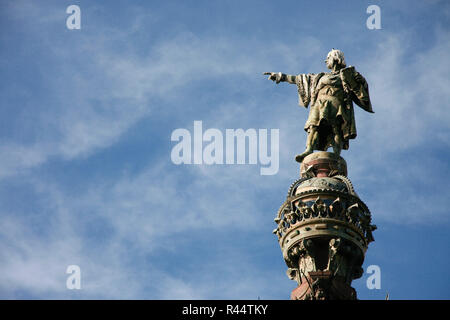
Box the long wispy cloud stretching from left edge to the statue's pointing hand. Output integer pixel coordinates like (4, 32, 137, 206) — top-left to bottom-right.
(0, 3, 320, 180)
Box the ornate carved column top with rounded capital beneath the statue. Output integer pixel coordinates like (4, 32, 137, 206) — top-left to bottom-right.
(273, 151, 376, 300)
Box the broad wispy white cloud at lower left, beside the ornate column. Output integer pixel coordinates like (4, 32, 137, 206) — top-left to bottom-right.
(0, 159, 284, 299)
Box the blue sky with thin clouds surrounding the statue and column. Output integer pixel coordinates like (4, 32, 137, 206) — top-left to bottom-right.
(0, 0, 450, 299)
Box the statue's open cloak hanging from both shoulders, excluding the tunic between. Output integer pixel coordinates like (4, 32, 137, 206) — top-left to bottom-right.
(296, 67, 373, 150)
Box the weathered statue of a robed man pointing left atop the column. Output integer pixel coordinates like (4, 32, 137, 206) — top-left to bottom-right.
(264, 49, 373, 162)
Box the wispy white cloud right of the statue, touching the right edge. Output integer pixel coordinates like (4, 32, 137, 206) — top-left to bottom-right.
(361, 31, 450, 152)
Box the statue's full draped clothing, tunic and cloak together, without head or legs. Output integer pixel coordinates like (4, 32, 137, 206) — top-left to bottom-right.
(295, 67, 373, 150)
